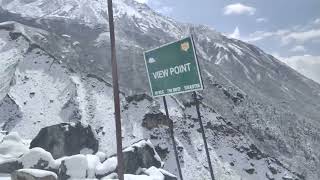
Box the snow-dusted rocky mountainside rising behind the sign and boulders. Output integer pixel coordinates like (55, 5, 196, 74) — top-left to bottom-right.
(0, 0, 320, 180)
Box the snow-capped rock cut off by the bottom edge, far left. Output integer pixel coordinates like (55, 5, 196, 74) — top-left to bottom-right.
(11, 169, 58, 180)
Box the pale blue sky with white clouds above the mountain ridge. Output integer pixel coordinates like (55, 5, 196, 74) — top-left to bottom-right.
(136, 0, 320, 83)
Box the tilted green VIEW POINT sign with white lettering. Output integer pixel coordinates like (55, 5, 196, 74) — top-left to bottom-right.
(144, 37, 203, 97)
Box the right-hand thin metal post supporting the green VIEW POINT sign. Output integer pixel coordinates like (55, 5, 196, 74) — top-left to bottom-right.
(192, 91, 214, 180)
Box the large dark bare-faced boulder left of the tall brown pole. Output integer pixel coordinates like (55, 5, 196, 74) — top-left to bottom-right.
(30, 123, 99, 159)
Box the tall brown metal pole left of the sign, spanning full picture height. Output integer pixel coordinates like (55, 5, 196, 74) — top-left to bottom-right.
(108, 0, 124, 180)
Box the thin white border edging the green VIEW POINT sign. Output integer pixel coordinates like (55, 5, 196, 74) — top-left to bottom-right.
(143, 35, 204, 97)
